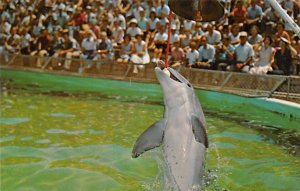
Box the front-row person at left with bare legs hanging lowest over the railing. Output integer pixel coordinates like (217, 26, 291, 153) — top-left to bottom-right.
(53, 30, 81, 70)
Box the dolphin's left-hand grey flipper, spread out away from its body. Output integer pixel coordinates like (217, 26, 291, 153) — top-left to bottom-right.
(132, 119, 165, 158)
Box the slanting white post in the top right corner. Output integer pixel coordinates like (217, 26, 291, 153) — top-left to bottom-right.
(266, 0, 300, 37)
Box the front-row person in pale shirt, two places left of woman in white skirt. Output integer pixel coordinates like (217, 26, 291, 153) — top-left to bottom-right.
(93, 32, 113, 66)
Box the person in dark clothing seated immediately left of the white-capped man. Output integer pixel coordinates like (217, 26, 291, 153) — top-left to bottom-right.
(213, 36, 235, 71)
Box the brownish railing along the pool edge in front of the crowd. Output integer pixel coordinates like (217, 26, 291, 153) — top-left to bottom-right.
(0, 54, 300, 103)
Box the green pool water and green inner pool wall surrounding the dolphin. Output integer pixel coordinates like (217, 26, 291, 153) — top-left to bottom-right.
(0, 71, 300, 191)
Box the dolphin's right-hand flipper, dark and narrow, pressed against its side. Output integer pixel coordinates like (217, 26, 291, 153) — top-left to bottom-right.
(192, 115, 208, 148)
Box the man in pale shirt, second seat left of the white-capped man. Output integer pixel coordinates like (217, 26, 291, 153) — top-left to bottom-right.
(194, 36, 216, 69)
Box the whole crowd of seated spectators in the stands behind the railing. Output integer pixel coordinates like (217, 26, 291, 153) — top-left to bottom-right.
(0, 0, 300, 75)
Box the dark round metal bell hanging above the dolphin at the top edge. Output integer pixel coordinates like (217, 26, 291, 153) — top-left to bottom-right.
(168, 0, 224, 22)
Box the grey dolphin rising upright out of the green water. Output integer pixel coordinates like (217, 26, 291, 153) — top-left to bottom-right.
(132, 67, 208, 191)
